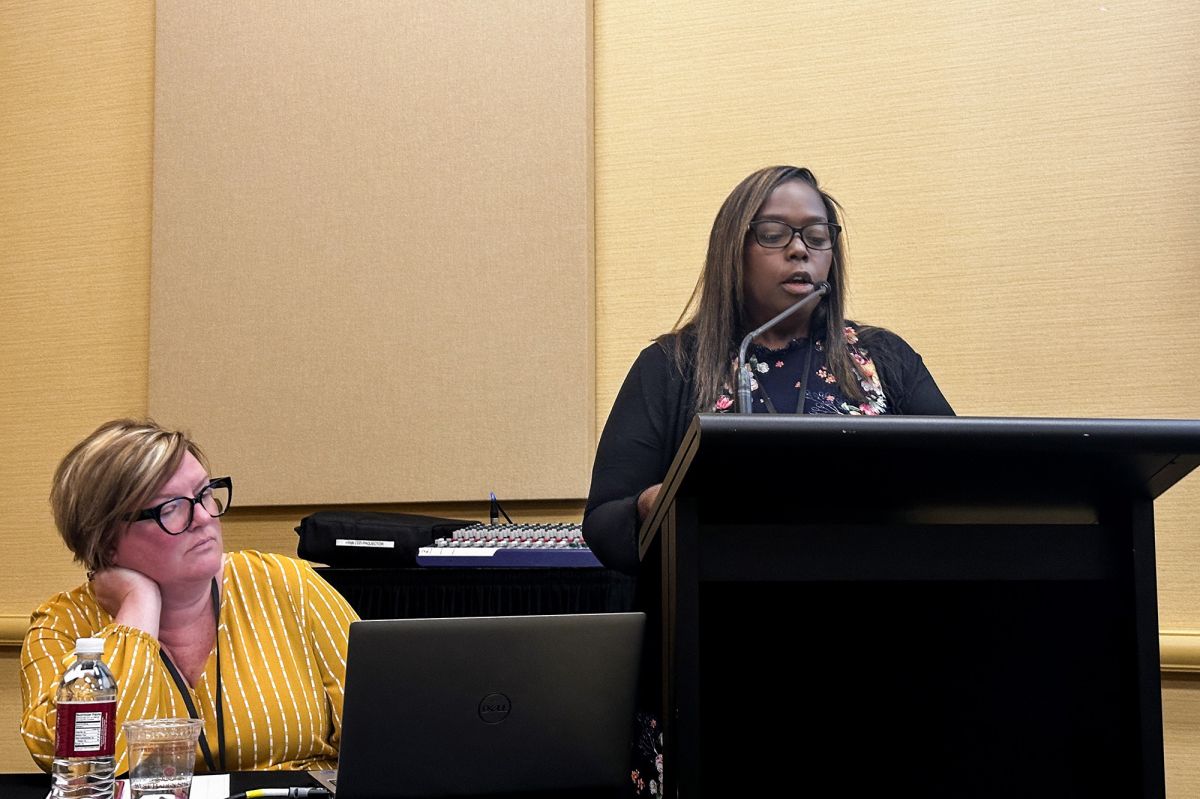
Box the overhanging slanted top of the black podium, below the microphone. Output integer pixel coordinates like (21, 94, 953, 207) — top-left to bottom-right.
(643, 414, 1200, 533)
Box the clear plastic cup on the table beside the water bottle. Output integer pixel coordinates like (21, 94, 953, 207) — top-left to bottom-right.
(124, 719, 203, 799)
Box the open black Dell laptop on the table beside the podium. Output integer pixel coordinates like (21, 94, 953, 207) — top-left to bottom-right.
(314, 613, 646, 799)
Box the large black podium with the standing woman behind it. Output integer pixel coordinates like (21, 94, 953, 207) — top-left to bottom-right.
(642, 414, 1200, 798)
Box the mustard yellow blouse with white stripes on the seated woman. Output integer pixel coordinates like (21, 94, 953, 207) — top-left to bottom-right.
(20, 551, 358, 774)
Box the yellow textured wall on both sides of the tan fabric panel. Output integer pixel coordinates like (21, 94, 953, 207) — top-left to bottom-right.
(0, 0, 1200, 782)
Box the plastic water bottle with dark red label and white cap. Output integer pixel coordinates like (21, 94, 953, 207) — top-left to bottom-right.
(50, 638, 116, 799)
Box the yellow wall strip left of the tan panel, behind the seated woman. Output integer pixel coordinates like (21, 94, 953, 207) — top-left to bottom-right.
(0, 0, 154, 771)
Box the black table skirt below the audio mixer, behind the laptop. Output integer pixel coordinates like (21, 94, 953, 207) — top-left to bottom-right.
(317, 566, 636, 619)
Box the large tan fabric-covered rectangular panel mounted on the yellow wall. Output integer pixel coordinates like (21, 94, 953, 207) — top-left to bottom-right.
(150, 0, 595, 505)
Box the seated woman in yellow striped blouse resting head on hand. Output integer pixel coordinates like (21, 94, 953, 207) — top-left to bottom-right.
(20, 420, 358, 773)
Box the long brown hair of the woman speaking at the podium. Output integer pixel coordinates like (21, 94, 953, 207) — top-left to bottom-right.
(671, 167, 864, 413)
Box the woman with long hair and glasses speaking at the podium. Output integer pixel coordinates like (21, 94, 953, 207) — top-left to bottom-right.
(583, 167, 954, 794)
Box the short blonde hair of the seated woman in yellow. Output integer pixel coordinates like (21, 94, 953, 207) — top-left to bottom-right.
(50, 419, 208, 571)
